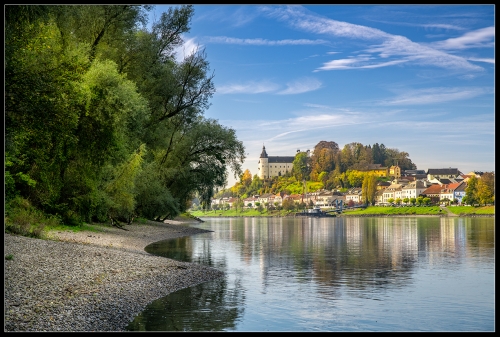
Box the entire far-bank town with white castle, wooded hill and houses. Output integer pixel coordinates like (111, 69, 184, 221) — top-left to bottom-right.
(205, 141, 495, 210)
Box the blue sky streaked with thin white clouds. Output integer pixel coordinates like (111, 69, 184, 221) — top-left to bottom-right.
(146, 5, 495, 187)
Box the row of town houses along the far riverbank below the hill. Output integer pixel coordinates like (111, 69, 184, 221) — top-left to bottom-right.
(211, 164, 494, 209)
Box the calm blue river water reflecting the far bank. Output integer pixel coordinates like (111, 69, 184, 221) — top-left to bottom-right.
(127, 217, 495, 332)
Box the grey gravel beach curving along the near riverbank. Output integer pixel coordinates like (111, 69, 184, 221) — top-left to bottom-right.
(4, 221, 223, 331)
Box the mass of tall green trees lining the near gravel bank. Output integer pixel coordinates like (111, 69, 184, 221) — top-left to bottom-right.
(4, 5, 245, 231)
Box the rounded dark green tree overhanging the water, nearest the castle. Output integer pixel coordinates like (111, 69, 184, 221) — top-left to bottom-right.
(155, 118, 245, 211)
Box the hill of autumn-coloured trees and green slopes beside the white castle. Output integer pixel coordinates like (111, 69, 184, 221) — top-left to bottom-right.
(216, 141, 417, 198)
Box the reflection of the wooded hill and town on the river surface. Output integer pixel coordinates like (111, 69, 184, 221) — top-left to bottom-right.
(198, 217, 492, 294)
